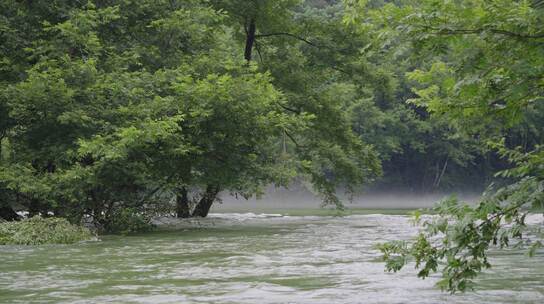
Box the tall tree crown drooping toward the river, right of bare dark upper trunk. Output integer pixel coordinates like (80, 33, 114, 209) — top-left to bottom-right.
(208, 1, 380, 208)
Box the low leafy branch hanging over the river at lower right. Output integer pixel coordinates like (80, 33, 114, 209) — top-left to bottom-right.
(378, 167, 544, 292)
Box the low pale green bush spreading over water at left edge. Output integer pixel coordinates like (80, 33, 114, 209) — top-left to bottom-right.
(0, 216, 93, 245)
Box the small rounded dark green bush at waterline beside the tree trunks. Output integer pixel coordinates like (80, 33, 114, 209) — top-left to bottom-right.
(104, 208, 155, 234)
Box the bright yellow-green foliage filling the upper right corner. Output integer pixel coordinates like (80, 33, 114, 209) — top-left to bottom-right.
(344, 0, 544, 132)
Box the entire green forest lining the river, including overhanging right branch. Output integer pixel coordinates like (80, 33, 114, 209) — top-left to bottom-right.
(0, 0, 544, 290)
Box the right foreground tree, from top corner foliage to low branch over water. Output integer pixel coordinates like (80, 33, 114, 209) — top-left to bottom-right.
(346, 0, 544, 292)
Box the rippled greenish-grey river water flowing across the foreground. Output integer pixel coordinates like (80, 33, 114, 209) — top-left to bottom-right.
(0, 212, 544, 304)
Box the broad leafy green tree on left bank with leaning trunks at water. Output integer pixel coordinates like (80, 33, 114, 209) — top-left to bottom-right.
(0, 0, 379, 230)
